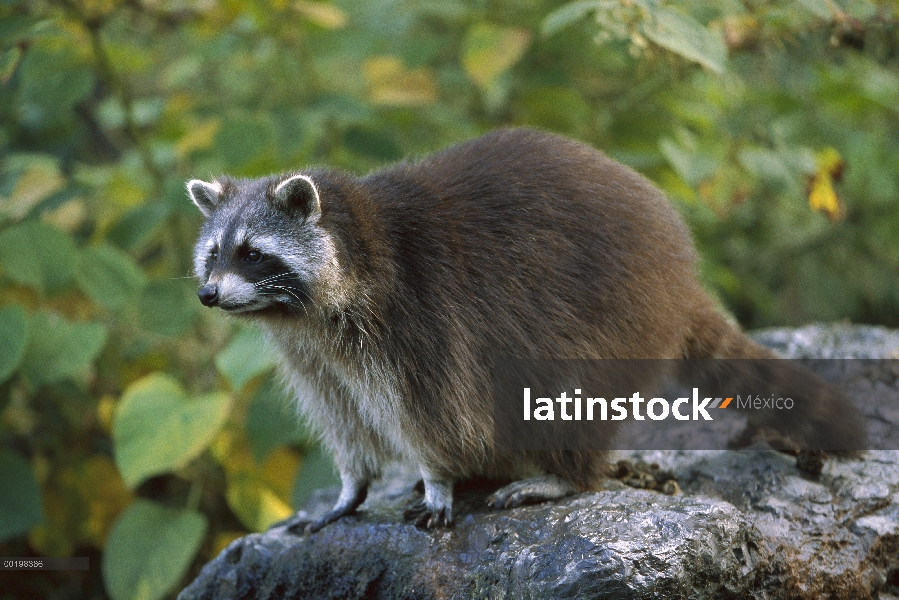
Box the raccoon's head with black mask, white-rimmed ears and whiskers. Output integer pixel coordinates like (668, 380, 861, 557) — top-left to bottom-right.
(187, 175, 339, 314)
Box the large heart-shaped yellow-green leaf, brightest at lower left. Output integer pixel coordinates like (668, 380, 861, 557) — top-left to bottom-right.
(112, 374, 231, 488)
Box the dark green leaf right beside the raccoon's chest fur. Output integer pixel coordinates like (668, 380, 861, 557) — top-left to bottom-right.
(247, 377, 310, 463)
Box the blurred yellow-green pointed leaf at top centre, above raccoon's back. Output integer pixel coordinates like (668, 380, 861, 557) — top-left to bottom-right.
(462, 23, 531, 90)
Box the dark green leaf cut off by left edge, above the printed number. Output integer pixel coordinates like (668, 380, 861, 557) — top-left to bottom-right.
(0, 448, 44, 541)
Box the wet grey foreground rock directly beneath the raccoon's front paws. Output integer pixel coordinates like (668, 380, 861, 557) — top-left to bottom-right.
(181, 484, 759, 598)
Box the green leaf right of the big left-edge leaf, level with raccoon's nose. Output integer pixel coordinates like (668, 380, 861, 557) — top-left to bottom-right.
(75, 246, 147, 311)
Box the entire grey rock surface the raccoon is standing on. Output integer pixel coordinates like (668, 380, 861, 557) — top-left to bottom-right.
(179, 325, 899, 600)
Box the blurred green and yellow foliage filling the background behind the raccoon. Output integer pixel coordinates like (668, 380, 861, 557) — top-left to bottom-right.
(0, 0, 899, 600)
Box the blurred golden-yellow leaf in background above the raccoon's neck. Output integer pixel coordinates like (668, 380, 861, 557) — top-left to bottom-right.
(364, 56, 437, 106)
